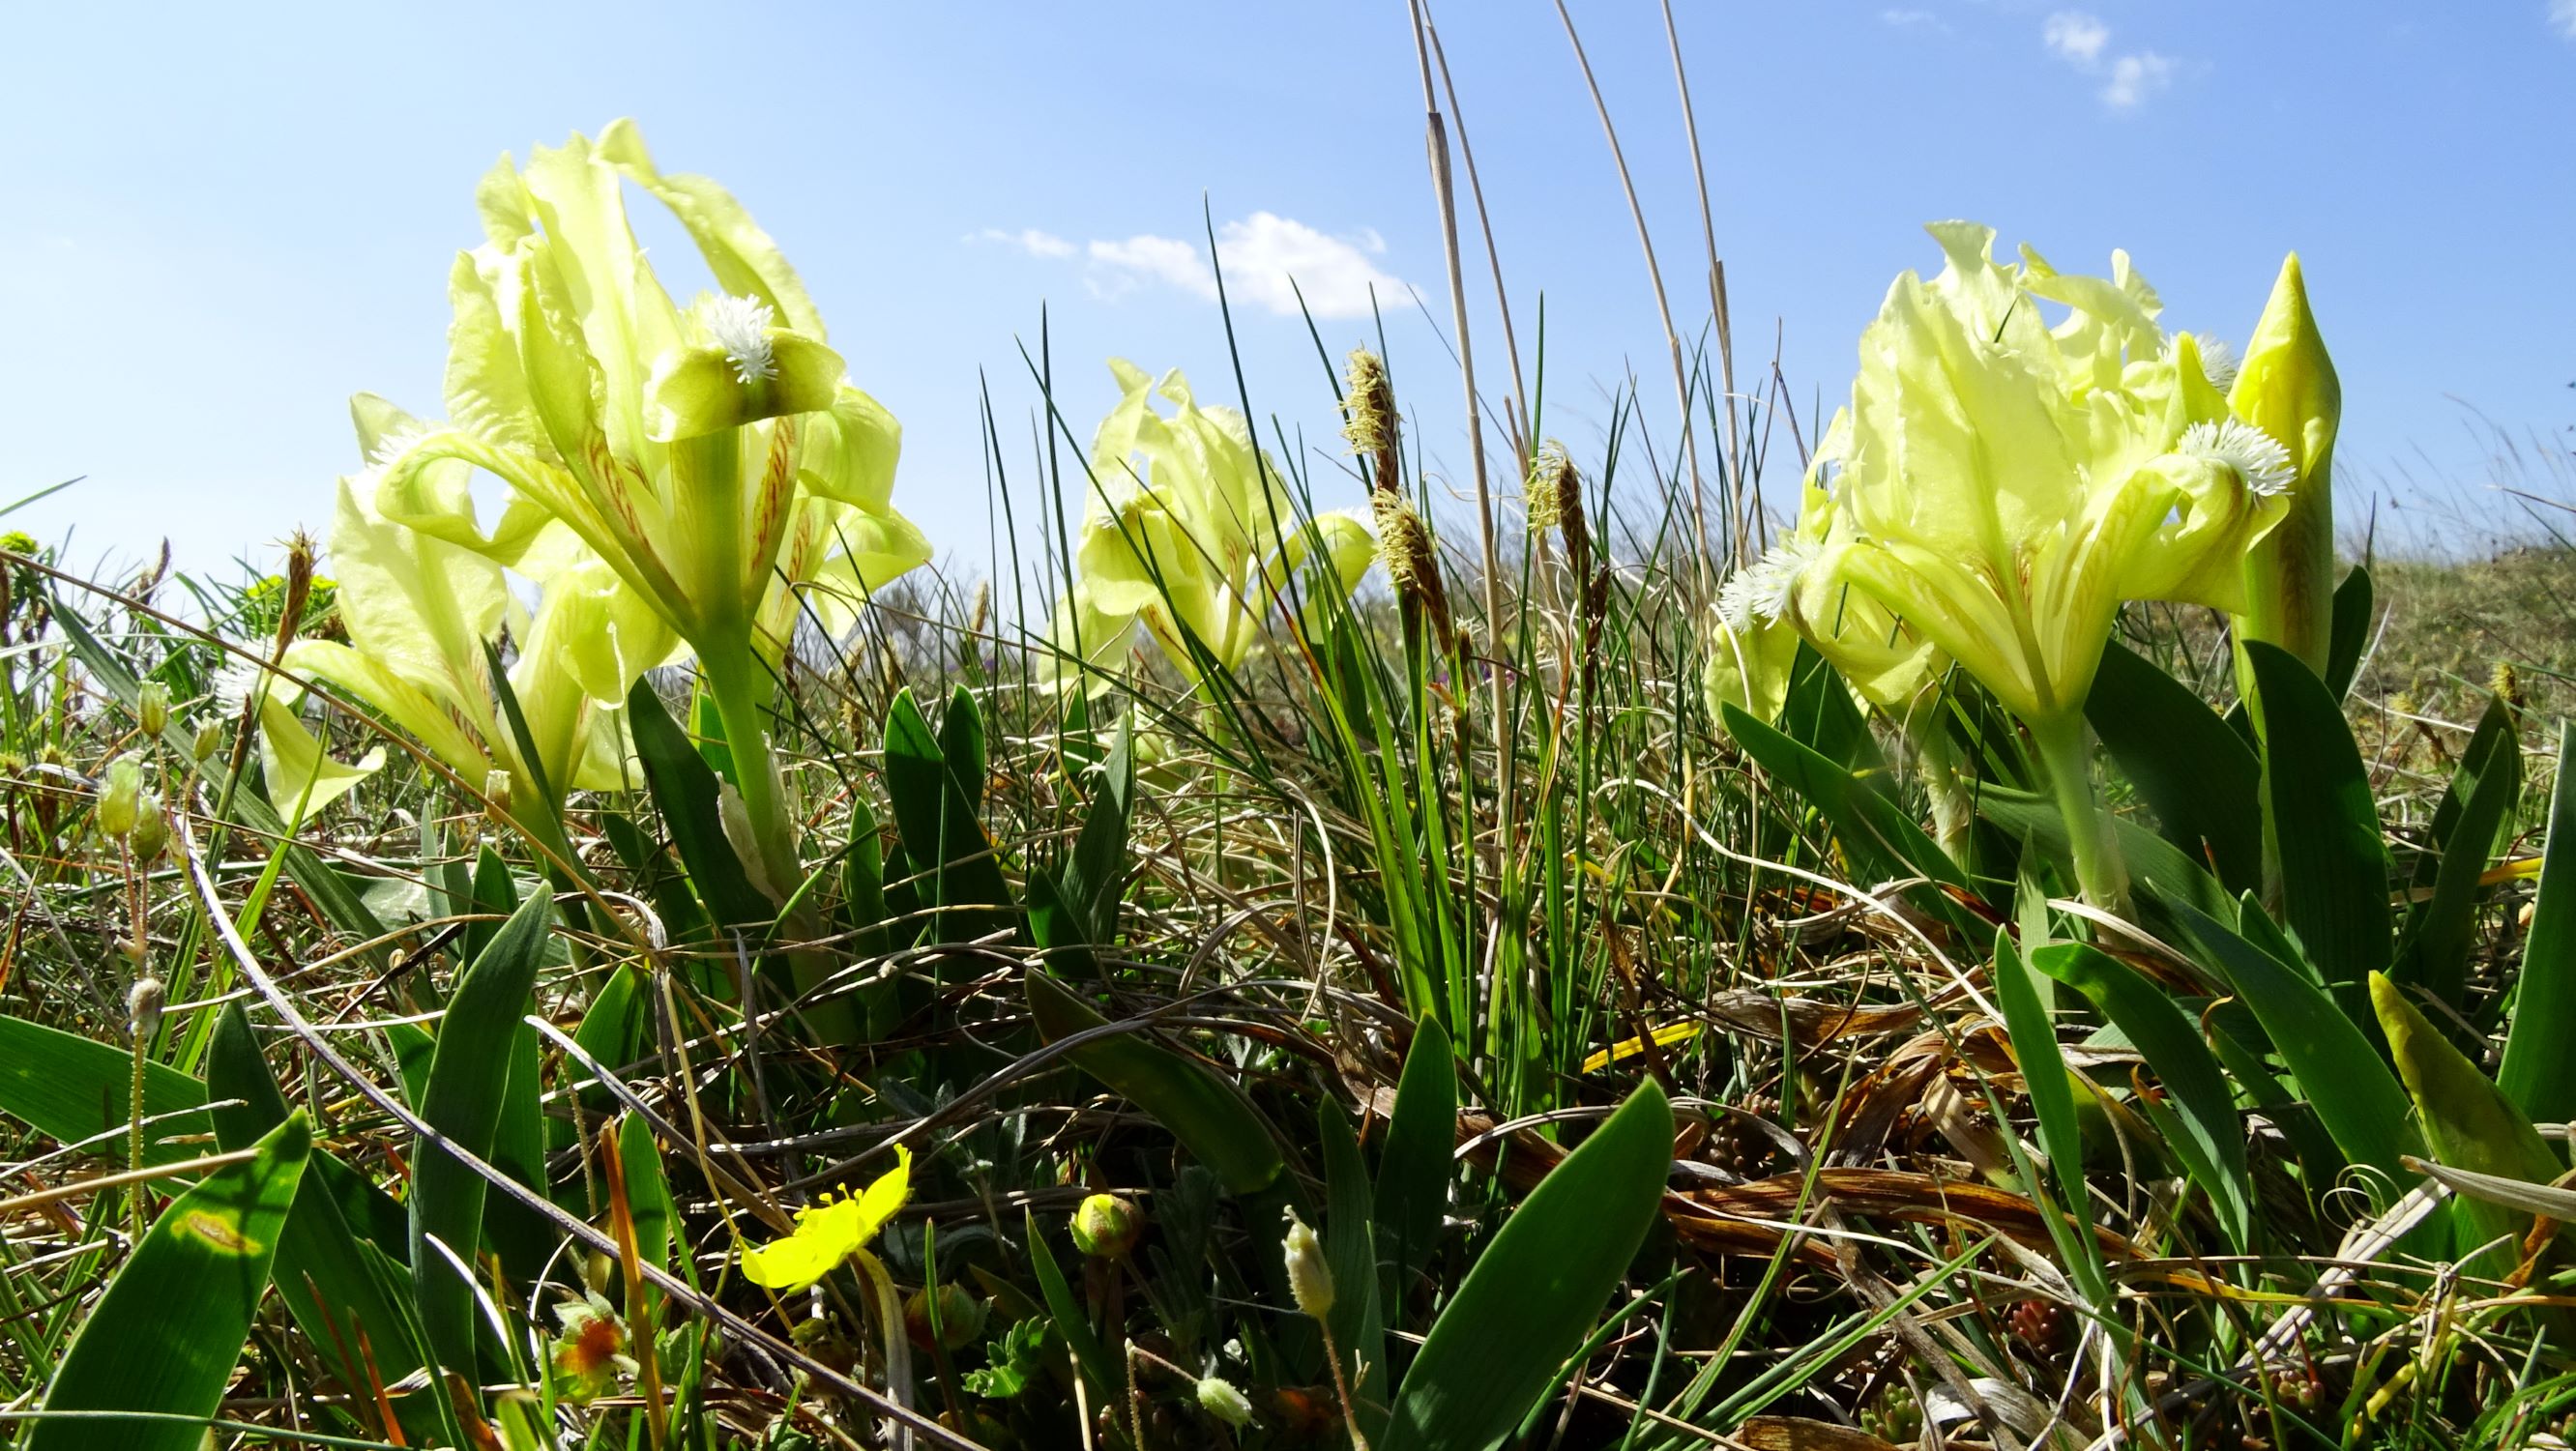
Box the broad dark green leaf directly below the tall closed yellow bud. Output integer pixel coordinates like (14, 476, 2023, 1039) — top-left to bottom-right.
(2243, 639, 2393, 1015)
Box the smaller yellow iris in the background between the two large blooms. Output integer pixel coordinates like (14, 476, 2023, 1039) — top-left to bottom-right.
(1056, 359, 1376, 683)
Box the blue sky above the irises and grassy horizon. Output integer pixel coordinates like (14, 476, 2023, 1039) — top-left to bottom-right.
(0, 0, 2576, 569)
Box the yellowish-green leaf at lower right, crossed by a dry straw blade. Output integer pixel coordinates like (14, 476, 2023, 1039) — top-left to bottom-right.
(2370, 974, 2558, 1273)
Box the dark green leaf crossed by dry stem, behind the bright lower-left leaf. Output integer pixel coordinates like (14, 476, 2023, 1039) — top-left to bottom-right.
(206, 1002, 420, 1386)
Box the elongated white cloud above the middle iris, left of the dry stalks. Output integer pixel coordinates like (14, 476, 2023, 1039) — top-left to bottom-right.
(969, 212, 1412, 317)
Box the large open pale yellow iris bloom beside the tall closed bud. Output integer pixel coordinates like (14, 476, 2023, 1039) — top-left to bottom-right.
(1819, 221, 2288, 724)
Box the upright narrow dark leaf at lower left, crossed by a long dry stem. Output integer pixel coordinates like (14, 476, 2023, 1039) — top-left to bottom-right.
(412, 894, 554, 1377)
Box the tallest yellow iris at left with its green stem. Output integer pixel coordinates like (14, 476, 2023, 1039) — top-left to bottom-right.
(352, 121, 930, 884)
